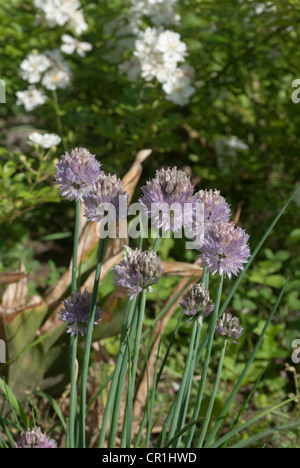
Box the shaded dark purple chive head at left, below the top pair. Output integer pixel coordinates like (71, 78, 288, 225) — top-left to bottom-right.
(59, 290, 101, 336)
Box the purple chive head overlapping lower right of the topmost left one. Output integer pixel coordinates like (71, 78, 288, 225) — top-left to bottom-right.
(83, 172, 128, 222)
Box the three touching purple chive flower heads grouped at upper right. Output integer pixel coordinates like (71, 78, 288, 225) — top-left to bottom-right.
(139, 167, 250, 278)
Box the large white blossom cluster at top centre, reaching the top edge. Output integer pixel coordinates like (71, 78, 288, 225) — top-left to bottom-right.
(119, 0, 195, 106)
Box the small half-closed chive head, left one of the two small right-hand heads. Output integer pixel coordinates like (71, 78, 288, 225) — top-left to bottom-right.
(179, 284, 215, 323)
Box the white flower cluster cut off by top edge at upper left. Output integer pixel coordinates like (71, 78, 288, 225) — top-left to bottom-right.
(34, 0, 87, 34)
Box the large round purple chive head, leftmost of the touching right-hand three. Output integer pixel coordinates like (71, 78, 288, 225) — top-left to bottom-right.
(139, 167, 194, 232)
